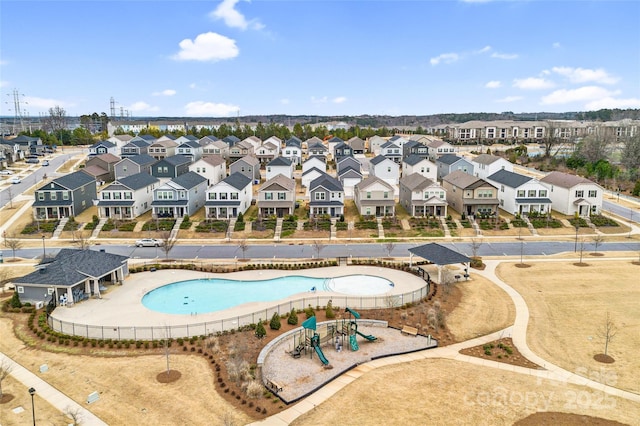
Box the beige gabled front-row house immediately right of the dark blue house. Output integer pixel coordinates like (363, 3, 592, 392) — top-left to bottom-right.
(353, 176, 396, 217)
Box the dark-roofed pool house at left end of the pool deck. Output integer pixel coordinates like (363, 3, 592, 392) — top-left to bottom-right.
(11, 248, 129, 307)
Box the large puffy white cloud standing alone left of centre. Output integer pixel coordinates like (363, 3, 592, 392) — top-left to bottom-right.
(172, 32, 240, 62)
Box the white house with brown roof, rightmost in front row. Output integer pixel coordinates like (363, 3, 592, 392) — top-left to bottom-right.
(540, 172, 604, 217)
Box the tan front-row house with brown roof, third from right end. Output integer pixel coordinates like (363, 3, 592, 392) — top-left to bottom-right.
(442, 170, 500, 215)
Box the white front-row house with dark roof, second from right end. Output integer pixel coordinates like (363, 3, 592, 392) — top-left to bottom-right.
(486, 170, 551, 215)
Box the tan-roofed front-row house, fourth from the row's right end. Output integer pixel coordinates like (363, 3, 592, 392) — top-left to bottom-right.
(398, 173, 447, 217)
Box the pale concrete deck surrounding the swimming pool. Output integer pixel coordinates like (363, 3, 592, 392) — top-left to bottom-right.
(51, 266, 436, 327)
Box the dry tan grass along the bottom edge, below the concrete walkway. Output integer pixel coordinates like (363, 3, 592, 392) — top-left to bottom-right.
(292, 359, 640, 425)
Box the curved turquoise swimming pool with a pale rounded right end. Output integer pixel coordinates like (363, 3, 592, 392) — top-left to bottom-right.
(142, 275, 393, 315)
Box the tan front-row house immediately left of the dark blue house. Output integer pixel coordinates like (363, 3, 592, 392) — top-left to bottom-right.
(256, 175, 296, 217)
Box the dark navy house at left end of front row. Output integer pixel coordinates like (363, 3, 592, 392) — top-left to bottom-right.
(33, 171, 98, 220)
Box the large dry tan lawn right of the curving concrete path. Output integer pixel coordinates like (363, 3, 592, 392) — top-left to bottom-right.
(497, 256, 640, 392)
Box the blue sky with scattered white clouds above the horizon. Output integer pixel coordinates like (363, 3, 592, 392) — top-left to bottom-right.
(0, 0, 640, 117)
